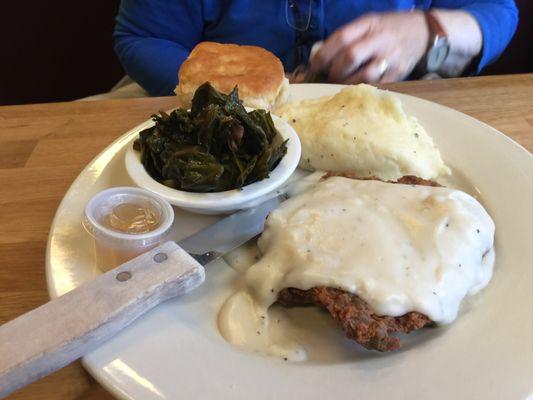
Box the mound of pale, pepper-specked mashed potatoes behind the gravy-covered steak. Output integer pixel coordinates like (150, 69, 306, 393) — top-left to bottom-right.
(275, 85, 450, 180)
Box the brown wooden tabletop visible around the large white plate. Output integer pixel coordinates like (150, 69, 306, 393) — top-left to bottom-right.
(0, 74, 533, 400)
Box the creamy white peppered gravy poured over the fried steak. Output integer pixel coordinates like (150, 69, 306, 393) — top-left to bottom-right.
(219, 177, 494, 361)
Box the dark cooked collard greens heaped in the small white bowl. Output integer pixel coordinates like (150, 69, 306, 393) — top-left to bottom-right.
(133, 82, 287, 192)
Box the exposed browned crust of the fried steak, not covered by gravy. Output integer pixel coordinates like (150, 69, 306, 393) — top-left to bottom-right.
(278, 172, 441, 351)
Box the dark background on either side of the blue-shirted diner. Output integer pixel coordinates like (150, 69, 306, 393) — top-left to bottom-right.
(0, 0, 533, 105)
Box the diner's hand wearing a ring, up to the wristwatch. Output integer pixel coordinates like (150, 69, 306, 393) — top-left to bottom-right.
(311, 11, 429, 84)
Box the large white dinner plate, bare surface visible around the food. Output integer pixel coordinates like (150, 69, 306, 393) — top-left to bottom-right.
(46, 85, 533, 400)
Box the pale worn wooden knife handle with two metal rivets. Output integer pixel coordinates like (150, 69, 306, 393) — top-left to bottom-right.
(0, 242, 205, 397)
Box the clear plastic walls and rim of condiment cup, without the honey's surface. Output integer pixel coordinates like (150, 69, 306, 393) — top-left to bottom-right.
(83, 187, 174, 271)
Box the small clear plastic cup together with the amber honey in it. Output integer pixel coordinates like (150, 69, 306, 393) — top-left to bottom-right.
(83, 187, 174, 271)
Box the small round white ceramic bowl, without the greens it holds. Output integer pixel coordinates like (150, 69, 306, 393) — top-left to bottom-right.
(125, 115, 301, 214)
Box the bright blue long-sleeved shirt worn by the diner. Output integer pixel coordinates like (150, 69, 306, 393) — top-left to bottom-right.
(114, 0, 518, 96)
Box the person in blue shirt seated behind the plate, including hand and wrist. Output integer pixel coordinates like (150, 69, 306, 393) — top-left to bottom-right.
(114, 0, 518, 96)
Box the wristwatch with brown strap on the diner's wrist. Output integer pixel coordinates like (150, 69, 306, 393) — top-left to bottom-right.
(421, 11, 450, 73)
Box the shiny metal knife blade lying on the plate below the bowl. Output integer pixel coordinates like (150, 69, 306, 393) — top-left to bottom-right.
(178, 195, 286, 265)
